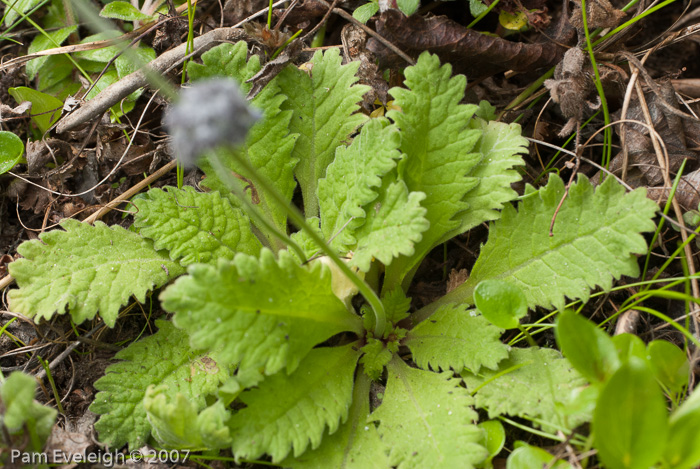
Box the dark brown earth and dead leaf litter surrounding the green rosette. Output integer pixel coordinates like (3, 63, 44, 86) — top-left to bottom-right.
(0, 0, 700, 467)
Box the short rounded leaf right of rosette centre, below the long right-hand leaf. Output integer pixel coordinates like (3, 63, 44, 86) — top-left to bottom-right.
(403, 304, 508, 372)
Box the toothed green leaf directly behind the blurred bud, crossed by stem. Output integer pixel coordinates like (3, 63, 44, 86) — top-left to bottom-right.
(187, 41, 298, 236)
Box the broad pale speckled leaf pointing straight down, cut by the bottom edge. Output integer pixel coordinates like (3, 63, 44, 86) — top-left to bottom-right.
(370, 358, 488, 469)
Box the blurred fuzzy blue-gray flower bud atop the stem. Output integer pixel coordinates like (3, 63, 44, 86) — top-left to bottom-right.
(163, 78, 262, 167)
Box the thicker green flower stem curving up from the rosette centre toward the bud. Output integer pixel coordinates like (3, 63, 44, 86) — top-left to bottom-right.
(216, 146, 386, 338)
